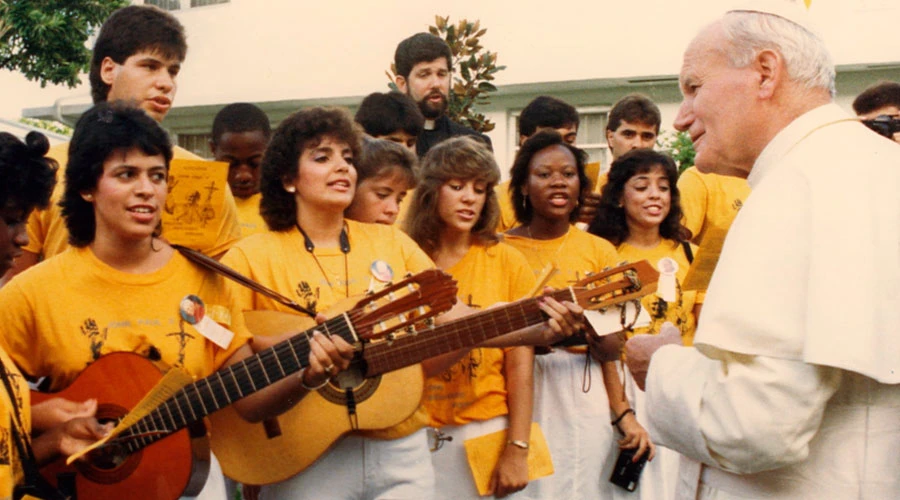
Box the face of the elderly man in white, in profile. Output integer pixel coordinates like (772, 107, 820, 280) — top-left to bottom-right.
(674, 25, 759, 172)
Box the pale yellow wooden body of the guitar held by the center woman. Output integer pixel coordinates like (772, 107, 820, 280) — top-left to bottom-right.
(210, 311, 425, 484)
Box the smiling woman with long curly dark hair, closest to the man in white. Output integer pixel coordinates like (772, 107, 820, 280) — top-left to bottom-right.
(589, 149, 699, 498)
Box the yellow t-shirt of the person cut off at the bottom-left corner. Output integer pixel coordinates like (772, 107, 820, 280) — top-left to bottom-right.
(0, 349, 31, 498)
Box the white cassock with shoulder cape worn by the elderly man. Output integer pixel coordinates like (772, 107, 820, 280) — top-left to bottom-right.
(647, 104, 900, 499)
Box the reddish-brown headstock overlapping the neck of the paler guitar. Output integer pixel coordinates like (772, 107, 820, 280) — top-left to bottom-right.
(347, 269, 457, 339)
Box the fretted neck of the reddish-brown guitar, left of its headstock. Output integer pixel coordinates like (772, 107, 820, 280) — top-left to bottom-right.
(121, 314, 356, 453)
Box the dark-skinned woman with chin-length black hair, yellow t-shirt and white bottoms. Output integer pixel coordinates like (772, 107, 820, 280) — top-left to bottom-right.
(506, 130, 654, 498)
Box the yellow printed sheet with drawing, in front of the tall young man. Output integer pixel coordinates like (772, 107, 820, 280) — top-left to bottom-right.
(162, 159, 228, 248)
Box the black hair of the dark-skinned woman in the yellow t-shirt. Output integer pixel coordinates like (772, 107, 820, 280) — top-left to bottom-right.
(509, 130, 591, 224)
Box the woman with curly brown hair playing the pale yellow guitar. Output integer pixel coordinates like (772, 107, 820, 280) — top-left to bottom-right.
(223, 108, 580, 500)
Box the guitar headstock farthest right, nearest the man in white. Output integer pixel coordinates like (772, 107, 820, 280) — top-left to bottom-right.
(570, 260, 659, 309)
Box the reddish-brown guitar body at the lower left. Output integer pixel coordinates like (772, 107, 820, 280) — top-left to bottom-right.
(31, 352, 209, 500)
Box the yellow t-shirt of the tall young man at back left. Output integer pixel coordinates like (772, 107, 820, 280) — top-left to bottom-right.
(24, 142, 241, 259)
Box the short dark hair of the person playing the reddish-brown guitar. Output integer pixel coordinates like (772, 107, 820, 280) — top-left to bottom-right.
(60, 102, 172, 247)
